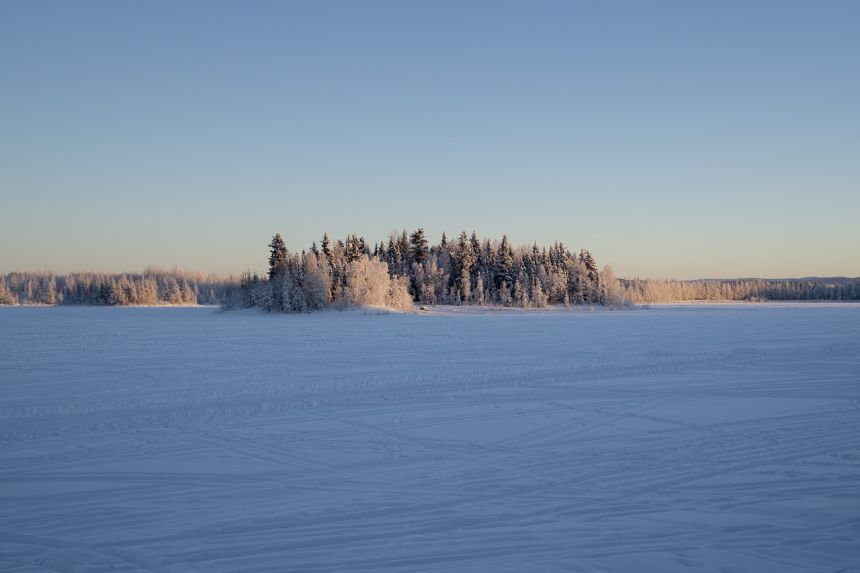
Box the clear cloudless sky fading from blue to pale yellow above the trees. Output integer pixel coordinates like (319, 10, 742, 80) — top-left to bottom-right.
(0, 0, 860, 279)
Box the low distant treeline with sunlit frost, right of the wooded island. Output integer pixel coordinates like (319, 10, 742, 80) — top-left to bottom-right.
(619, 277, 860, 303)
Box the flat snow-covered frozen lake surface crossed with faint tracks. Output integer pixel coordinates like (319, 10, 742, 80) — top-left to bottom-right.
(0, 304, 860, 573)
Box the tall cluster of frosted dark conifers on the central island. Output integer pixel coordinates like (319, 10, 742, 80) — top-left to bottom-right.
(226, 228, 623, 312)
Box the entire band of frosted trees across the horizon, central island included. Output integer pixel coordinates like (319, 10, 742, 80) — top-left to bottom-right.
(5, 239, 860, 312)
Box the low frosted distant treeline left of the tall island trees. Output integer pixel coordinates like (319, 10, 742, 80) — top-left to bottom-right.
(0, 268, 233, 306)
